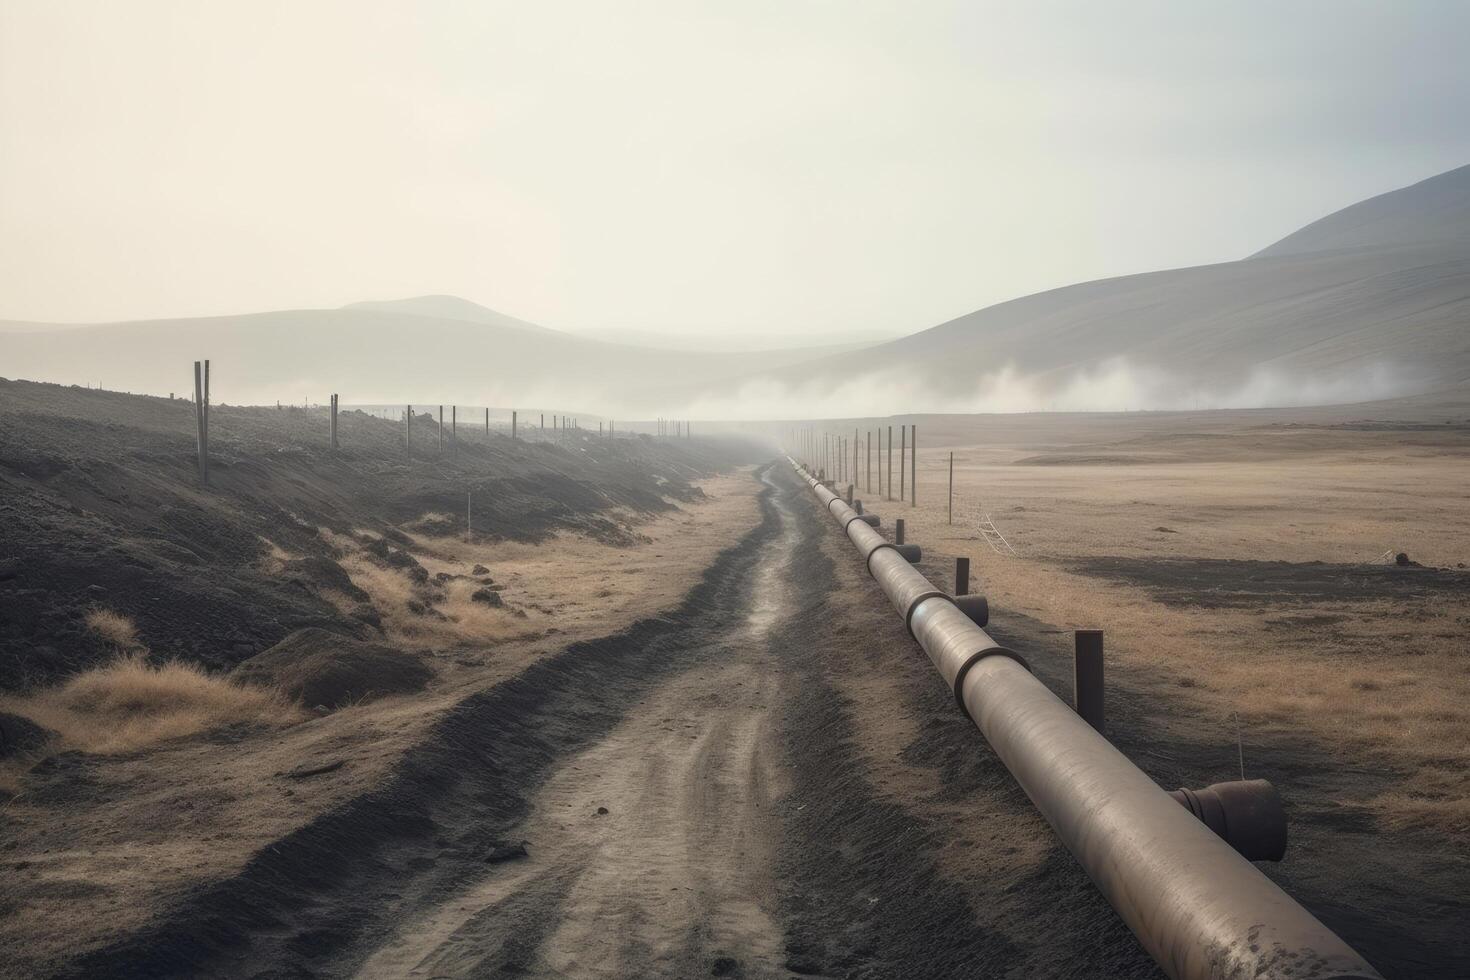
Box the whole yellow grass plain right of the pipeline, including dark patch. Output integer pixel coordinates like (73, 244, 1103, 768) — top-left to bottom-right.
(844, 413, 1470, 835)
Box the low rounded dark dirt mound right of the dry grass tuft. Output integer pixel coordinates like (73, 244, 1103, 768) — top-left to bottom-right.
(232, 627, 434, 708)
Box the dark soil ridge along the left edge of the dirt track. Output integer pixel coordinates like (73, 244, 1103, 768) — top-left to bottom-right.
(62, 470, 781, 977)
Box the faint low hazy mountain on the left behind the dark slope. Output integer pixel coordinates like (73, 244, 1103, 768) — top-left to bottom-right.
(0, 297, 858, 417)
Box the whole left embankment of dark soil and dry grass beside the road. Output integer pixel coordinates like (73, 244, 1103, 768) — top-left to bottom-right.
(0, 382, 757, 976)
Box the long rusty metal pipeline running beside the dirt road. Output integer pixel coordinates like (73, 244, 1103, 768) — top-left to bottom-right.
(788, 457, 1382, 980)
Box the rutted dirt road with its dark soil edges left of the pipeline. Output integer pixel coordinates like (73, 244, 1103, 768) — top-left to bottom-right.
(51, 466, 1466, 977)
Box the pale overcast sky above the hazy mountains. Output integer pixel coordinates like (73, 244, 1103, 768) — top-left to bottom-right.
(0, 0, 1470, 338)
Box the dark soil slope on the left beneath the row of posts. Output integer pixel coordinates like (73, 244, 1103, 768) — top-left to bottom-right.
(0, 381, 753, 689)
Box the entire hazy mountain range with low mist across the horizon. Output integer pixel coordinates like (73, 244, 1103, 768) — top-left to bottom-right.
(0, 167, 1470, 419)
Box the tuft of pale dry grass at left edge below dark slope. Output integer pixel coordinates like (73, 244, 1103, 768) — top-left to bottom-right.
(0, 654, 304, 754)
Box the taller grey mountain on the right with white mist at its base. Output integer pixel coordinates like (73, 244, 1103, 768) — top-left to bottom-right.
(673, 167, 1470, 416)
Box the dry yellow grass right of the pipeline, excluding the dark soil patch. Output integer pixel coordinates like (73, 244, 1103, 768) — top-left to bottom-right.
(870, 420, 1470, 833)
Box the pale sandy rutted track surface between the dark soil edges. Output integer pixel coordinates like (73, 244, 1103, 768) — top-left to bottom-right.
(349, 470, 794, 977)
